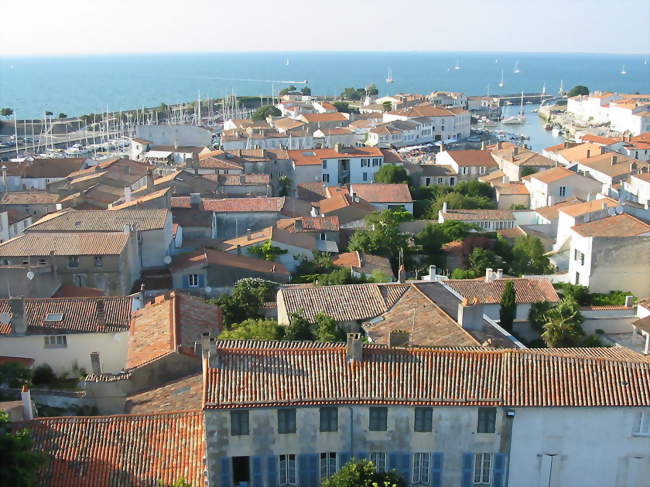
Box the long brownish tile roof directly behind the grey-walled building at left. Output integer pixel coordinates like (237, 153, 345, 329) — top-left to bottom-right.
(28, 208, 169, 232)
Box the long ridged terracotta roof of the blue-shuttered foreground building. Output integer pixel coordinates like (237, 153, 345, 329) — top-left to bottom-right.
(205, 341, 650, 408)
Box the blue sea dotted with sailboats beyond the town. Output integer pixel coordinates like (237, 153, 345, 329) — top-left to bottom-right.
(0, 52, 650, 118)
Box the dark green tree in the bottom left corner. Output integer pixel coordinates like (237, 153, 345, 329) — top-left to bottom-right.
(0, 412, 46, 487)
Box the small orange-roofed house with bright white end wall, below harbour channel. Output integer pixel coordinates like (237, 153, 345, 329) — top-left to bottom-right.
(522, 166, 603, 210)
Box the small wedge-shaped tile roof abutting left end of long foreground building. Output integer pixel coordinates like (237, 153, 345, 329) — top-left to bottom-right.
(125, 374, 203, 414)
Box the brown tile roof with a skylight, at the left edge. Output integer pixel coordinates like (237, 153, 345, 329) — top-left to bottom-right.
(0, 296, 133, 335)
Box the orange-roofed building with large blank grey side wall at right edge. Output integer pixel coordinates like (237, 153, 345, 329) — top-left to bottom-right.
(569, 214, 650, 296)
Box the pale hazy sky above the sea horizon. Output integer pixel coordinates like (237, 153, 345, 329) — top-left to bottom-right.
(0, 0, 650, 57)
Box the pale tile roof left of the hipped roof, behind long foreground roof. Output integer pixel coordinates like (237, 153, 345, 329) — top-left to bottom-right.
(277, 284, 409, 321)
